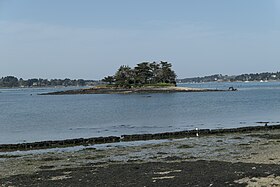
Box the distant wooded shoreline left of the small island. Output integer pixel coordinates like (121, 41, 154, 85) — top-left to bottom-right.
(0, 76, 96, 88)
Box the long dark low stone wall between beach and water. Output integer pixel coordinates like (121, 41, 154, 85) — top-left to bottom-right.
(0, 124, 280, 152)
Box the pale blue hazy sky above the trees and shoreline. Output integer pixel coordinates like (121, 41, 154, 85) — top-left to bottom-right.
(0, 0, 280, 79)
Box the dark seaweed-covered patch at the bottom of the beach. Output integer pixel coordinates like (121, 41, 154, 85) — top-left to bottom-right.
(0, 160, 280, 187)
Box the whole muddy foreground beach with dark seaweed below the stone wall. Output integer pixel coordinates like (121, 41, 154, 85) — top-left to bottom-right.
(0, 129, 280, 186)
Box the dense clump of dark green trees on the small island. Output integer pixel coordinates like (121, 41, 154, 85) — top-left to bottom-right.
(102, 61, 176, 87)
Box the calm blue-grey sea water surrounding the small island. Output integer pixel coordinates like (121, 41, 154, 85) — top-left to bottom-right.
(0, 82, 280, 144)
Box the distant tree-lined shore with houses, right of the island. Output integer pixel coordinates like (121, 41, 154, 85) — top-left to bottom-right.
(177, 72, 280, 83)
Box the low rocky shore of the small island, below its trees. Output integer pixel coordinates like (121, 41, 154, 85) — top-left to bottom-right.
(39, 87, 228, 95)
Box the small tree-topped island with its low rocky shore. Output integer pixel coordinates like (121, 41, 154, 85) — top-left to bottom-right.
(41, 61, 226, 95)
